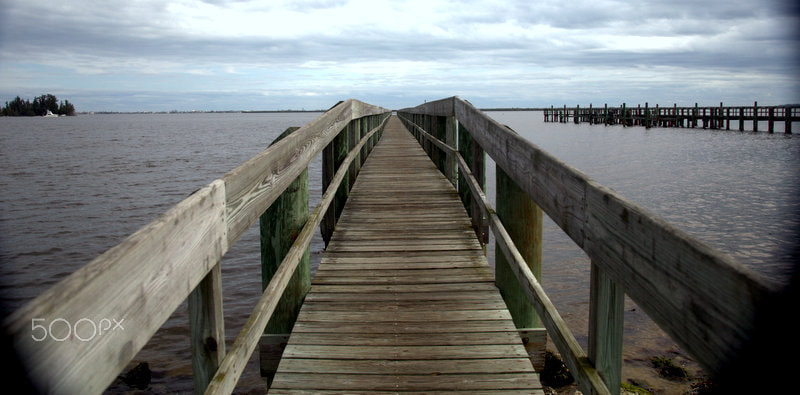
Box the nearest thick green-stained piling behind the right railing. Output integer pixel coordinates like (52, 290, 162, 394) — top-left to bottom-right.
(495, 166, 542, 328)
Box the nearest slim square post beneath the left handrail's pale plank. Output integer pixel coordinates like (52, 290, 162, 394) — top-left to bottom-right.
(188, 262, 225, 394)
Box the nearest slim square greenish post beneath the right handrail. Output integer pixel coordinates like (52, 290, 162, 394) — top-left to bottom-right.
(588, 263, 625, 394)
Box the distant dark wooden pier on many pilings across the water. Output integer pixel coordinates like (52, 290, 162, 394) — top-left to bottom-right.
(543, 102, 800, 134)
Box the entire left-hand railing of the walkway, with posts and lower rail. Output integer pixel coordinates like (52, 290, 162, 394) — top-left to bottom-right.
(3, 100, 389, 394)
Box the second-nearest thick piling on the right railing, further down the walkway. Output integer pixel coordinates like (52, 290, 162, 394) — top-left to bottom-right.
(458, 123, 489, 245)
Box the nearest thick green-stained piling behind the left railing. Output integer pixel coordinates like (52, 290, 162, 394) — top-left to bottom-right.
(259, 128, 311, 382)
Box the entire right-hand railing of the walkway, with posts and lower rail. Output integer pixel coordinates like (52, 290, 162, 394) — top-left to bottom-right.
(398, 97, 774, 393)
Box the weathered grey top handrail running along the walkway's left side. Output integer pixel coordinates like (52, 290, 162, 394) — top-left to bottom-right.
(2, 99, 389, 394)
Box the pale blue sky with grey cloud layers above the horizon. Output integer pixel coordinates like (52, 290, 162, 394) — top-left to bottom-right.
(0, 0, 800, 112)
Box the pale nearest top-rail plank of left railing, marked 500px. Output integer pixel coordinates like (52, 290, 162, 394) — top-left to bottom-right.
(3, 180, 228, 394)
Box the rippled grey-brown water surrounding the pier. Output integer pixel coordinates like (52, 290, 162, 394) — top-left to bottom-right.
(0, 112, 800, 392)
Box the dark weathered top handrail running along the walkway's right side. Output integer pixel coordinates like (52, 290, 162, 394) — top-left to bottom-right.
(398, 97, 776, 392)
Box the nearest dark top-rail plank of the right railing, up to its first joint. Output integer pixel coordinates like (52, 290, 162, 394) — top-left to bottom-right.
(585, 184, 772, 380)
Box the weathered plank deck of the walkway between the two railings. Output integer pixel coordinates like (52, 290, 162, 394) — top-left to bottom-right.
(270, 117, 543, 393)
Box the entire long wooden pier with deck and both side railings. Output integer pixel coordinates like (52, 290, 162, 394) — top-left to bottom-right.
(3, 97, 777, 394)
